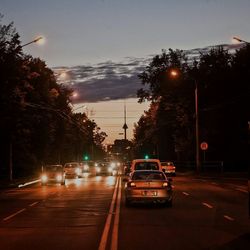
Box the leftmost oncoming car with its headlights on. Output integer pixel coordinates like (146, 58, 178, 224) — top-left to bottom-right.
(41, 165, 65, 185)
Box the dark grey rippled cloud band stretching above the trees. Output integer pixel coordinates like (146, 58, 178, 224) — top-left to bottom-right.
(53, 44, 242, 103)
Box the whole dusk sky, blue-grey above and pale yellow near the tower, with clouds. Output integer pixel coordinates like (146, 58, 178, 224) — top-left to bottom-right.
(0, 0, 250, 142)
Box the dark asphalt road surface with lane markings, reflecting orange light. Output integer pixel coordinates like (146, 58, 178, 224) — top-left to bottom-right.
(0, 176, 250, 250)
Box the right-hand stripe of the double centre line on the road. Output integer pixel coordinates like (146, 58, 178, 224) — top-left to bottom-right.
(110, 177, 121, 250)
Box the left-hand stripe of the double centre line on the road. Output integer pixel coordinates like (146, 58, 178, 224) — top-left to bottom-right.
(98, 178, 119, 250)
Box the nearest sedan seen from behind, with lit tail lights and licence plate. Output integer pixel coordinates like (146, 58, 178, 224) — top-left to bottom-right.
(125, 170, 173, 206)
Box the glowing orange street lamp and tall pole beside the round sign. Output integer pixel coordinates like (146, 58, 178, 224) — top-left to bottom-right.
(170, 69, 201, 173)
